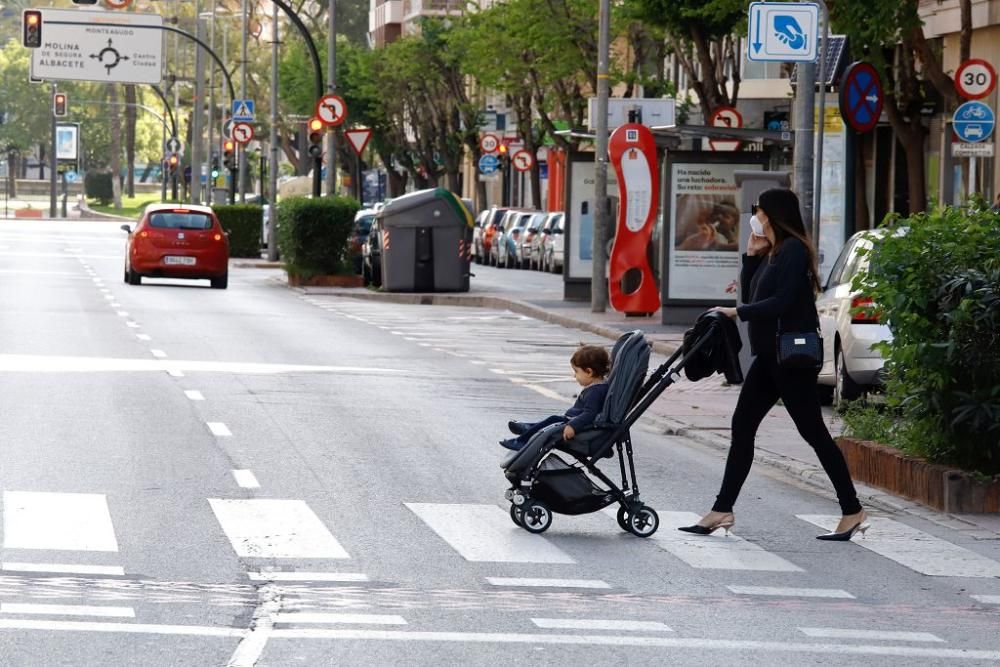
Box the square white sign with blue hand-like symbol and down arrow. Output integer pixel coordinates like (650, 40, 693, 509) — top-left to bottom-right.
(747, 2, 819, 62)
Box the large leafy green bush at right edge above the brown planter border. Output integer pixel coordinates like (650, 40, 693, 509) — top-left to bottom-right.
(854, 201, 1000, 475)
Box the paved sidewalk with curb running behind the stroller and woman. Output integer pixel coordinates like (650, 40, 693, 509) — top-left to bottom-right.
(297, 265, 1000, 539)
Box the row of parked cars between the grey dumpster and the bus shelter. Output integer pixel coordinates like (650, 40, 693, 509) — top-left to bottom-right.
(472, 206, 565, 273)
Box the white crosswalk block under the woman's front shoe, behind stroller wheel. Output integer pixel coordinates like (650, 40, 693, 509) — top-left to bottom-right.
(640, 509, 802, 572)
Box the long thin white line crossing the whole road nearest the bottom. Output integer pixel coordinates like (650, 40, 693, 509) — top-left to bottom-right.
(0, 618, 1000, 662)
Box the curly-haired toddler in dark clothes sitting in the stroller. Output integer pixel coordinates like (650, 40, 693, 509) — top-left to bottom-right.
(500, 345, 611, 451)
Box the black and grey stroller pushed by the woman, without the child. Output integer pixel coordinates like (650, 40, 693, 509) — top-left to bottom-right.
(501, 314, 742, 537)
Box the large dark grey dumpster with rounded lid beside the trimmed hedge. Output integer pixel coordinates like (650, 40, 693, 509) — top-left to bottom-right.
(378, 188, 473, 292)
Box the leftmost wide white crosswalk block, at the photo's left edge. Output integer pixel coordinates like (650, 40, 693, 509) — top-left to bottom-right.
(3, 491, 118, 551)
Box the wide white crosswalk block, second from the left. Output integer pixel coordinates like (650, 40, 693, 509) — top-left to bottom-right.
(208, 498, 350, 558)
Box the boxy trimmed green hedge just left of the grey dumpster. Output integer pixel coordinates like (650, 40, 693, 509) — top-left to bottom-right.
(278, 197, 361, 278)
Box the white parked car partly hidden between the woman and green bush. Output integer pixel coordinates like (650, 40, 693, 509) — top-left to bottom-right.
(816, 229, 892, 405)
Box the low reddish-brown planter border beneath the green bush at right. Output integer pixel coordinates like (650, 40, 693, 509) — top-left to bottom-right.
(837, 437, 1000, 514)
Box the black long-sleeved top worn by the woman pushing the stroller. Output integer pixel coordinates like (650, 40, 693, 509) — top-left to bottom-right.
(736, 237, 819, 359)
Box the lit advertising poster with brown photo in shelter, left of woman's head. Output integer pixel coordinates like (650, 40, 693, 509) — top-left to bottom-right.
(666, 158, 763, 304)
